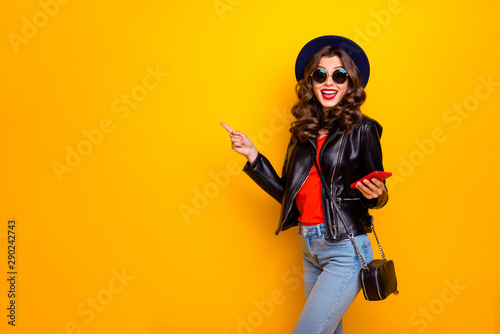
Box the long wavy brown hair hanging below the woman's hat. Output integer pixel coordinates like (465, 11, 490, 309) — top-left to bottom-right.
(290, 46, 366, 142)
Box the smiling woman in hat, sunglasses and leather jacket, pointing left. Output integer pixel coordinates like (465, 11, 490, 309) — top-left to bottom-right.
(222, 36, 388, 334)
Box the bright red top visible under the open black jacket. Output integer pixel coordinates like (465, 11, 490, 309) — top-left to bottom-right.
(295, 136, 327, 225)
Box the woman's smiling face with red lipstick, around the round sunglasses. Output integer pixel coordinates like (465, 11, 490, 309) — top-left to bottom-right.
(312, 56, 349, 111)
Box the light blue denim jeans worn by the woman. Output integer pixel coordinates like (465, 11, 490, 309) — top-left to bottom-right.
(293, 223, 373, 334)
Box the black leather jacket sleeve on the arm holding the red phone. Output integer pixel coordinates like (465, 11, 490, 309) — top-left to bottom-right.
(361, 121, 389, 209)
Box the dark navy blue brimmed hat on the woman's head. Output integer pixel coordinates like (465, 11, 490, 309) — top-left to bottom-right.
(295, 35, 370, 87)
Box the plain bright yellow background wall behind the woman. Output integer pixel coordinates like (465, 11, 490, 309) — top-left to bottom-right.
(0, 0, 500, 334)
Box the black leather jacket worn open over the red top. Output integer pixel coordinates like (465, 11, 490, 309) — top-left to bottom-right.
(243, 116, 388, 241)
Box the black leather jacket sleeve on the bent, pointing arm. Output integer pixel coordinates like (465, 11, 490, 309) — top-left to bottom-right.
(243, 141, 291, 204)
